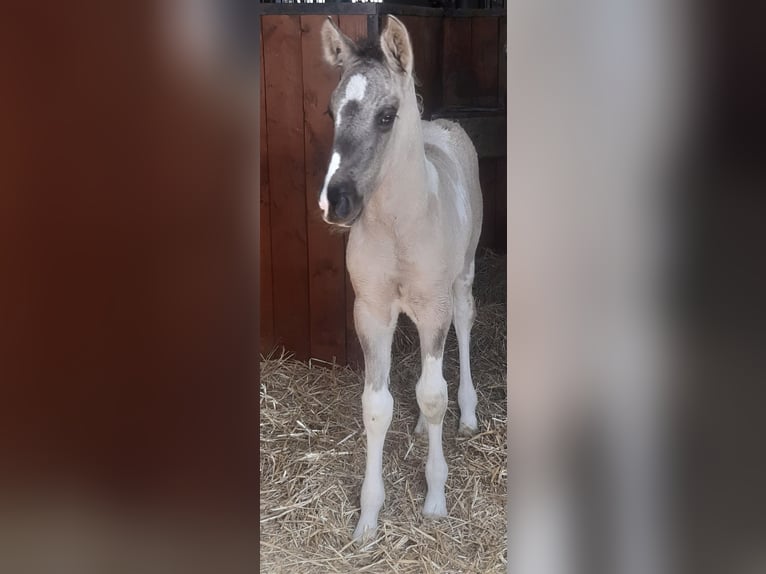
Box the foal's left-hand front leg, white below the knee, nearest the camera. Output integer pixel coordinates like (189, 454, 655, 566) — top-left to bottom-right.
(354, 299, 398, 541)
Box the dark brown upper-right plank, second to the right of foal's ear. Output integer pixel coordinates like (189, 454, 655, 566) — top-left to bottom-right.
(442, 17, 476, 107)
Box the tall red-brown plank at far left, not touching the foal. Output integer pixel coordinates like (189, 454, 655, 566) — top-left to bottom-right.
(261, 15, 310, 359)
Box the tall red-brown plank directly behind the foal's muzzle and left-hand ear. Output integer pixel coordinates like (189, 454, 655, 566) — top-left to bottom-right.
(301, 15, 346, 364)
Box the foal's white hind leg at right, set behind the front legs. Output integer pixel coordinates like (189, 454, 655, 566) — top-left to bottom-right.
(452, 261, 479, 436)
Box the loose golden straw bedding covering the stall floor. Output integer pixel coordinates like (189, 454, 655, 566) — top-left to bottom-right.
(260, 252, 507, 574)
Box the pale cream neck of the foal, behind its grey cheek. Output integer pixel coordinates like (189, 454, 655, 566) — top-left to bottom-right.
(365, 84, 428, 225)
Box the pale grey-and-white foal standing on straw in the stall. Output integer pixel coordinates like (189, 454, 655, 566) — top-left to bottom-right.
(319, 16, 482, 540)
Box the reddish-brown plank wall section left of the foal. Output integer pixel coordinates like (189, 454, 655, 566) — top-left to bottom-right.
(261, 14, 367, 364)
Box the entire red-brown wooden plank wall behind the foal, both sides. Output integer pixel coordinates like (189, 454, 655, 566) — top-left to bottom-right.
(261, 14, 505, 364)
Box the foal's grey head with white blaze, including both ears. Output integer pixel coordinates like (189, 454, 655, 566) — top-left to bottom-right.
(319, 16, 413, 227)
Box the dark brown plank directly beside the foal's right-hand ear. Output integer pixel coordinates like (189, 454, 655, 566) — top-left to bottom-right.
(399, 16, 441, 118)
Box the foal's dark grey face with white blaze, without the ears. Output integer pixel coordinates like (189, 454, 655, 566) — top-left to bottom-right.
(320, 59, 399, 226)
